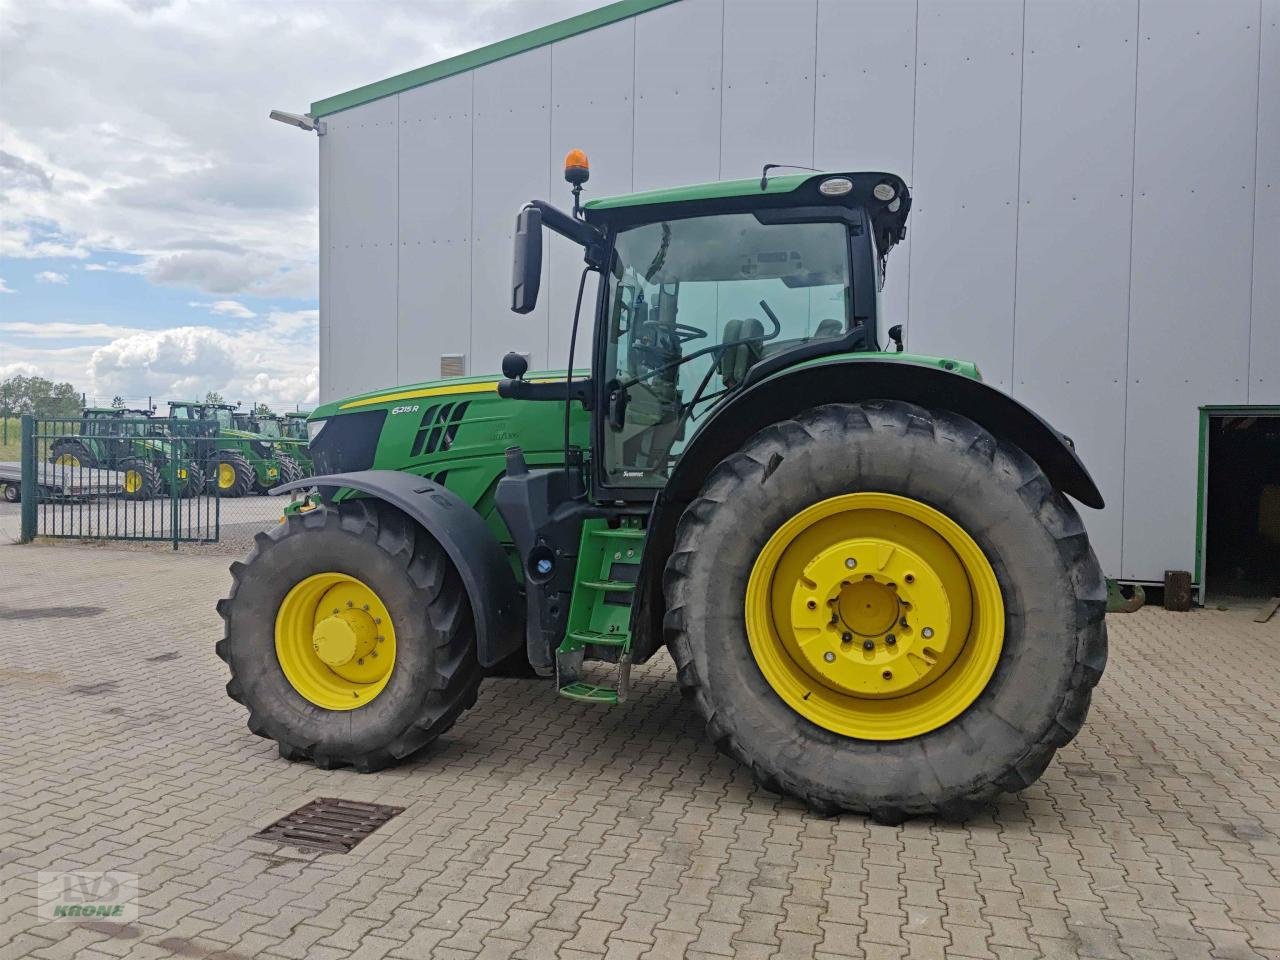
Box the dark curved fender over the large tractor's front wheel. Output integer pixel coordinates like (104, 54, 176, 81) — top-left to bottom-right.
(271, 470, 525, 667)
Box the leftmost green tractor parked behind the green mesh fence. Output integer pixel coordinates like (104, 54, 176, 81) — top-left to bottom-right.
(49, 407, 205, 500)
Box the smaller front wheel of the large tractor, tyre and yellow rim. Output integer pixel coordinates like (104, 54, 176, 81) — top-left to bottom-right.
(216, 499, 481, 773)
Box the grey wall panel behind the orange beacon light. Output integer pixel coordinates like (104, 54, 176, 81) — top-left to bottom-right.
(545, 19, 636, 369)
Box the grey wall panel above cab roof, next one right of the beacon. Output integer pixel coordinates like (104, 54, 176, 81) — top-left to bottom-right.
(632, 0, 724, 189)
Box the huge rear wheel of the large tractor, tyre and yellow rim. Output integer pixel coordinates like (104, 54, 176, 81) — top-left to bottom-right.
(664, 401, 1107, 823)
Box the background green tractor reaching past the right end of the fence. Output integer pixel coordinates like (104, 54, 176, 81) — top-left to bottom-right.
(169, 401, 280, 497)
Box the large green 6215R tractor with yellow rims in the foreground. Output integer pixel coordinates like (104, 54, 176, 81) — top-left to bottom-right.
(218, 161, 1107, 823)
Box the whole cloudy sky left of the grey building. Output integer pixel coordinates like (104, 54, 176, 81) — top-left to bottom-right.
(0, 0, 604, 408)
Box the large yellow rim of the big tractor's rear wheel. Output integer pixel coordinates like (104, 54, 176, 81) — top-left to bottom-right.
(746, 493, 1005, 740)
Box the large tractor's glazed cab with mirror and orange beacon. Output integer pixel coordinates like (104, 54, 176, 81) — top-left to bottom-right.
(499, 155, 911, 502)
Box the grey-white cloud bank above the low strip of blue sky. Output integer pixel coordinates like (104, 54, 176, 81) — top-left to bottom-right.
(0, 0, 598, 298)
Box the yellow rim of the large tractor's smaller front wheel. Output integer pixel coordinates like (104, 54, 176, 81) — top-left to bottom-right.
(275, 573, 396, 710)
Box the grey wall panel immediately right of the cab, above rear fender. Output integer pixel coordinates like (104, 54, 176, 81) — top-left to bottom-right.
(908, 0, 1023, 390)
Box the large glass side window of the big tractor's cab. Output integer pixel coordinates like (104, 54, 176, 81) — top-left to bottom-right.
(603, 214, 852, 485)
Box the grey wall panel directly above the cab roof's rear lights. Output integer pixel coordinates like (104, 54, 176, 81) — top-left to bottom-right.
(813, 0, 915, 350)
